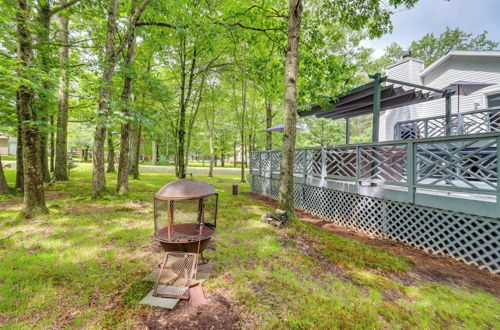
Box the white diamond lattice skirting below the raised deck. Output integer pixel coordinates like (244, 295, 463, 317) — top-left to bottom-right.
(252, 175, 500, 274)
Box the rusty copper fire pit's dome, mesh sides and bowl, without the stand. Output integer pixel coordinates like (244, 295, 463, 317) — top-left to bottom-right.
(154, 179, 218, 254)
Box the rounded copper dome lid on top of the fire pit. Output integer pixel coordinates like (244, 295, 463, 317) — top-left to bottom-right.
(155, 179, 216, 200)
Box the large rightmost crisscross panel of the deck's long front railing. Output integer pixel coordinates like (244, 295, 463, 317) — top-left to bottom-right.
(415, 138, 498, 191)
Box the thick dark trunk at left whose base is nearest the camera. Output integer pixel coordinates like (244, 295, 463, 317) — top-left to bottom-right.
(16, 0, 48, 218)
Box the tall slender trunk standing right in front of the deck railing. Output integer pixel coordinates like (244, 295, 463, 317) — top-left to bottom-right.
(278, 0, 302, 217)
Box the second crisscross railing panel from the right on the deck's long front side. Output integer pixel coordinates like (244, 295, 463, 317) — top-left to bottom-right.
(359, 144, 408, 183)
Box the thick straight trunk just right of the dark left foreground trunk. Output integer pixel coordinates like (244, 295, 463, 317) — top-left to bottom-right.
(54, 10, 69, 181)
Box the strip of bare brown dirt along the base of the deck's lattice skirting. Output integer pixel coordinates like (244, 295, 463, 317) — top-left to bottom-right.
(246, 194, 500, 297)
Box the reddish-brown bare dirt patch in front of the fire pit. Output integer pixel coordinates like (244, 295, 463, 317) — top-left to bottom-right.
(143, 294, 241, 330)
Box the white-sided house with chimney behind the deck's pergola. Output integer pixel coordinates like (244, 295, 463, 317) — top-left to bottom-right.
(379, 51, 500, 141)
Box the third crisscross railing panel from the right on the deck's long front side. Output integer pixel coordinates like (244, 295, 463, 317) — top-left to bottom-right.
(325, 147, 356, 179)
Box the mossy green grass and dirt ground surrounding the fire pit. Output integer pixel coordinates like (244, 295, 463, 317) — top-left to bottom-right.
(0, 166, 500, 329)
